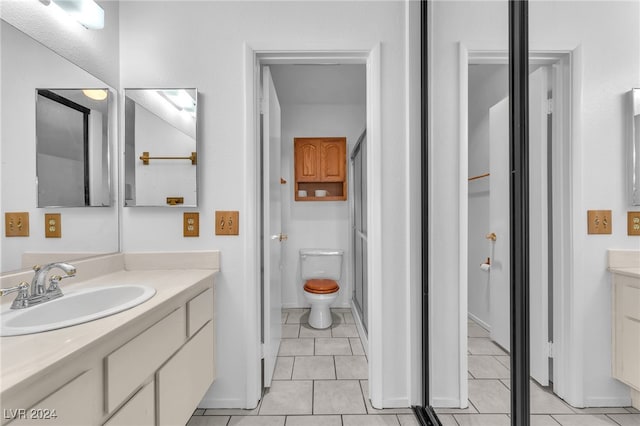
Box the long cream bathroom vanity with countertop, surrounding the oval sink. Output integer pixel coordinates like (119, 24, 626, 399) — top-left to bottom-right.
(0, 252, 219, 426)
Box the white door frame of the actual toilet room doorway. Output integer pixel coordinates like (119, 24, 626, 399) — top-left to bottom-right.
(243, 42, 383, 408)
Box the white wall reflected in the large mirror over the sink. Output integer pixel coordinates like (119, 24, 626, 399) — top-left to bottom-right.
(0, 21, 118, 271)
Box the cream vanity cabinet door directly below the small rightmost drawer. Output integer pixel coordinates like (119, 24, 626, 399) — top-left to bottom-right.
(156, 321, 215, 426)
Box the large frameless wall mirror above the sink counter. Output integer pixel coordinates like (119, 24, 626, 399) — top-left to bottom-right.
(0, 20, 120, 272)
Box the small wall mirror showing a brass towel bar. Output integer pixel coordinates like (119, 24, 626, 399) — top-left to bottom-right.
(124, 89, 198, 207)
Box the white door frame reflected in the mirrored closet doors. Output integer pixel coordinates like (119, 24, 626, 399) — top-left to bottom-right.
(458, 43, 582, 408)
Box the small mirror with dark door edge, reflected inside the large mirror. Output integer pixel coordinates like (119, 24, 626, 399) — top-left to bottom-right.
(36, 88, 111, 207)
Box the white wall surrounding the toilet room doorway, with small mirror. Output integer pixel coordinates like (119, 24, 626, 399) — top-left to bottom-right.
(120, 1, 419, 407)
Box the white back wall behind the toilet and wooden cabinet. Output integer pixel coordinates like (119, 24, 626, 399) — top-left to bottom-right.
(281, 103, 366, 308)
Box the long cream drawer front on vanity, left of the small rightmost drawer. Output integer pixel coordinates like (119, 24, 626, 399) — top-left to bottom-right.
(105, 306, 186, 413)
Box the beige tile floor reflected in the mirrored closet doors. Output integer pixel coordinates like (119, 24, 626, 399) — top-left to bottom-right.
(436, 321, 640, 426)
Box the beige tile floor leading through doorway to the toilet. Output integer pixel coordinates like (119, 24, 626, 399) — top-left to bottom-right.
(187, 309, 418, 426)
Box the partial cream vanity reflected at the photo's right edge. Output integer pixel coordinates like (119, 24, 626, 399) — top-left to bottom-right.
(609, 250, 640, 409)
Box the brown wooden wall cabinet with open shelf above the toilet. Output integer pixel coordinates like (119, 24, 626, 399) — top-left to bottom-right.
(293, 137, 347, 201)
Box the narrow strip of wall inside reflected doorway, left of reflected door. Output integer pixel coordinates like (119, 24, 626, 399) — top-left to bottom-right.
(467, 65, 509, 326)
